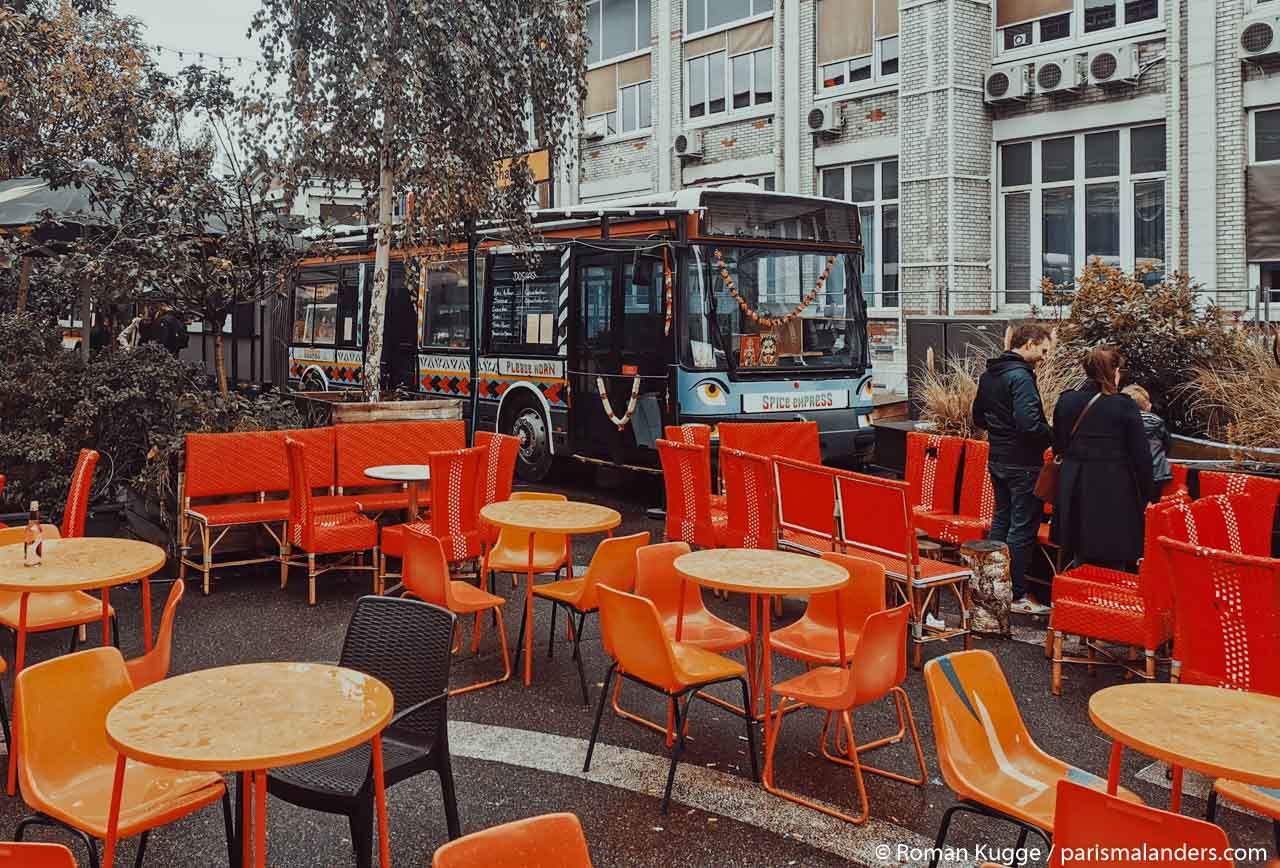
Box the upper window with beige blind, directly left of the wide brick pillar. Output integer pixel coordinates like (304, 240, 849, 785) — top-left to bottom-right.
(815, 0, 899, 90)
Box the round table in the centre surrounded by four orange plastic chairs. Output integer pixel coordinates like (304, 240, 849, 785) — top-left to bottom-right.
(673, 548, 849, 736)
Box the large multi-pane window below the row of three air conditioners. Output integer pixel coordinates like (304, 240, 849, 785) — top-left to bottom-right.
(998, 124, 1166, 305)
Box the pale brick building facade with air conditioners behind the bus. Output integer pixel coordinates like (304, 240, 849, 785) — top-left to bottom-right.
(556, 0, 1280, 388)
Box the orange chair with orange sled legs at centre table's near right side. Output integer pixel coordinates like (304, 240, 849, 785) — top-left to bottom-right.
(764, 598, 928, 823)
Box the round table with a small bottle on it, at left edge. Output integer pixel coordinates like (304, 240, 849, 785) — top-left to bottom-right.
(0, 536, 166, 795)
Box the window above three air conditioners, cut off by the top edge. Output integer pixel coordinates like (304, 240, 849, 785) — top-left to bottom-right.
(996, 0, 1162, 51)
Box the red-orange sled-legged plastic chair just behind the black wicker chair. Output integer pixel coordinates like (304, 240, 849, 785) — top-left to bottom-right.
(403, 527, 511, 696)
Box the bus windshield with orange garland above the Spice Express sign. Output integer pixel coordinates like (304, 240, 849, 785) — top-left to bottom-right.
(681, 239, 868, 373)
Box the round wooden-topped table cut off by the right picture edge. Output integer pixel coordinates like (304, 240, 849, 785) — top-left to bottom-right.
(1089, 684, 1280, 813)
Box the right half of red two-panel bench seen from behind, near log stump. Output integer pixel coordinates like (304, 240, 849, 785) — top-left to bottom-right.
(836, 471, 970, 667)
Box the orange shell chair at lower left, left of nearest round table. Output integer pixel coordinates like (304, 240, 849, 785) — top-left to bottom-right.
(14, 648, 236, 865)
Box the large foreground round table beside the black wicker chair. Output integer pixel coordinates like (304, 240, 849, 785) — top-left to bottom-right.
(102, 663, 396, 868)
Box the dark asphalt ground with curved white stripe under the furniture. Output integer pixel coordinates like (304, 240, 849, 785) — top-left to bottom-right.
(0, 458, 1271, 868)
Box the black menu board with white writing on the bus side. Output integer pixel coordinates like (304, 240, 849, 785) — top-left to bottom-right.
(489, 252, 559, 351)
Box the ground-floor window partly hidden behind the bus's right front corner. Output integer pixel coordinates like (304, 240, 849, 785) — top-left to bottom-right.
(818, 160, 901, 307)
